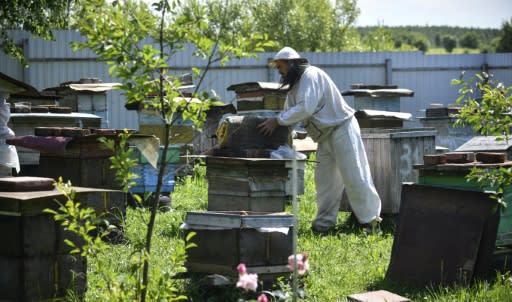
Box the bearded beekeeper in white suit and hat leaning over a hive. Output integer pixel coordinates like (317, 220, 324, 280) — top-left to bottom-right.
(258, 47, 382, 233)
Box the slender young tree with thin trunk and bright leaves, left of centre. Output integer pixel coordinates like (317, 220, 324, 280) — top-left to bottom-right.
(60, 0, 272, 301)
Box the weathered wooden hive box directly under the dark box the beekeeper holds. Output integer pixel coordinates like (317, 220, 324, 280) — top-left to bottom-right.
(206, 156, 305, 212)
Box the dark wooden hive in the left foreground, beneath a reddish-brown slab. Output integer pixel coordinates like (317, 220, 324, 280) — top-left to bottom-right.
(0, 187, 125, 301)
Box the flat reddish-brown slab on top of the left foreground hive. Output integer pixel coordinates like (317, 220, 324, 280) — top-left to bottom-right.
(0, 176, 55, 192)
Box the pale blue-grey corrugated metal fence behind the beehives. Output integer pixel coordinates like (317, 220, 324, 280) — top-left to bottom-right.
(0, 30, 512, 129)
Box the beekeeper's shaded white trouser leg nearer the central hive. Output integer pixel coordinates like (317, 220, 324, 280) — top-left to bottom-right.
(313, 141, 343, 229)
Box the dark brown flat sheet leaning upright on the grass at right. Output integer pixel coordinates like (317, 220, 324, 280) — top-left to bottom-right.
(386, 183, 499, 286)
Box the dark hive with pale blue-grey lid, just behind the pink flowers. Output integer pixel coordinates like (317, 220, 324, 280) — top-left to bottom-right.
(185, 211, 293, 276)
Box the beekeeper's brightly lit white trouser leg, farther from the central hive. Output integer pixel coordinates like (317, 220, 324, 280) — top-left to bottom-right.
(329, 117, 381, 223)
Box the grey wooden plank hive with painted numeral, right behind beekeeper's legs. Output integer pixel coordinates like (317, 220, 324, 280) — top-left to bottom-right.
(341, 128, 436, 214)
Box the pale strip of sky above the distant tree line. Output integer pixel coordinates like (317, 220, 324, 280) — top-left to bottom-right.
(355, 0, 512, 29)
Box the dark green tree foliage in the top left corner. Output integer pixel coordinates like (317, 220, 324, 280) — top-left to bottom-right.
(0, 0, 75, 65)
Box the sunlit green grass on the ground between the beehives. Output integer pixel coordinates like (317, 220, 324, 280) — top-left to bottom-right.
(87, 159, 512, 302)
